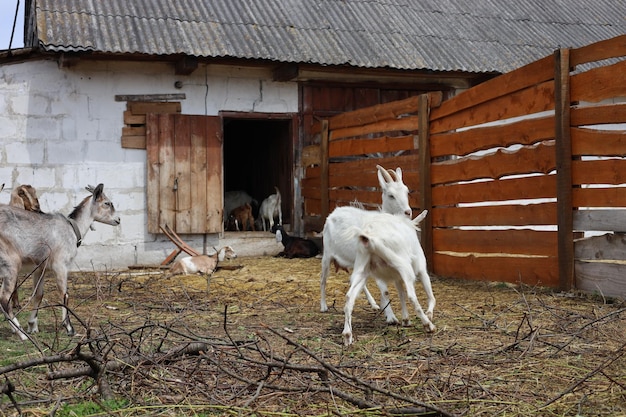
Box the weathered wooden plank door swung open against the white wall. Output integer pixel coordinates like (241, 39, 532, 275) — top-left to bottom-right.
(146, 113, 224, 234)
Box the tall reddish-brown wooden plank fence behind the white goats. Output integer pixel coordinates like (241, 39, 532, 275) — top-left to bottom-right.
(302, 36, 626, 296)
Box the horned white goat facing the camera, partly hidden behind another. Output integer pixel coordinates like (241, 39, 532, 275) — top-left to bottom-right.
(320, 165, 412, 323)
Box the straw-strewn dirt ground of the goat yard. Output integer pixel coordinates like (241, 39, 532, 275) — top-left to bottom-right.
(0, 257, 626, 416)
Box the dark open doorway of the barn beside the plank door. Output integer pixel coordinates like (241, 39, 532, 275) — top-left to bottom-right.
(223, 117, 293, 228)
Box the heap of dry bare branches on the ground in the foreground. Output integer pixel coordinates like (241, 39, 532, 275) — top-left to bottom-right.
(0, 308, 453, 416)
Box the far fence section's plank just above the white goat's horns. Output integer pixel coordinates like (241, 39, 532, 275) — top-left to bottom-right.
(328, 135, 416, 158)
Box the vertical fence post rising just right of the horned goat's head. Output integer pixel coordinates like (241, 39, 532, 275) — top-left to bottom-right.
(418, 94, 433, 271)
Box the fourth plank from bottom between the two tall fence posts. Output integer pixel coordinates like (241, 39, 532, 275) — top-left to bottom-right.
(432, 175, 556, 207)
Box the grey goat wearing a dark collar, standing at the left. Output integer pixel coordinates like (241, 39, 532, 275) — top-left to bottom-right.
(0, 184, 120, 340)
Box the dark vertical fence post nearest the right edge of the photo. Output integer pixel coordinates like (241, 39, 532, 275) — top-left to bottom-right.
(554, 48, 574, 291)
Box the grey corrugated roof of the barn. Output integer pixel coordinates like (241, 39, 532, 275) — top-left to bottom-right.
(32, 0, 626, 72)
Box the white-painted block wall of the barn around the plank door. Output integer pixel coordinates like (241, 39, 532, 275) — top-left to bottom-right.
(0, 61, 298, 270)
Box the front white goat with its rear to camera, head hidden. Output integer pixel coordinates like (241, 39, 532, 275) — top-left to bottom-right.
(342, 212, 436, 346)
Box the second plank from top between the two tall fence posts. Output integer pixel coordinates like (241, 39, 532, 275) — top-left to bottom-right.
(430, 81, 554, 135)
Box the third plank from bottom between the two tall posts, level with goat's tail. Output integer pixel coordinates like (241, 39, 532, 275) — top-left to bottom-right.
(429, 203, 556, 227)
